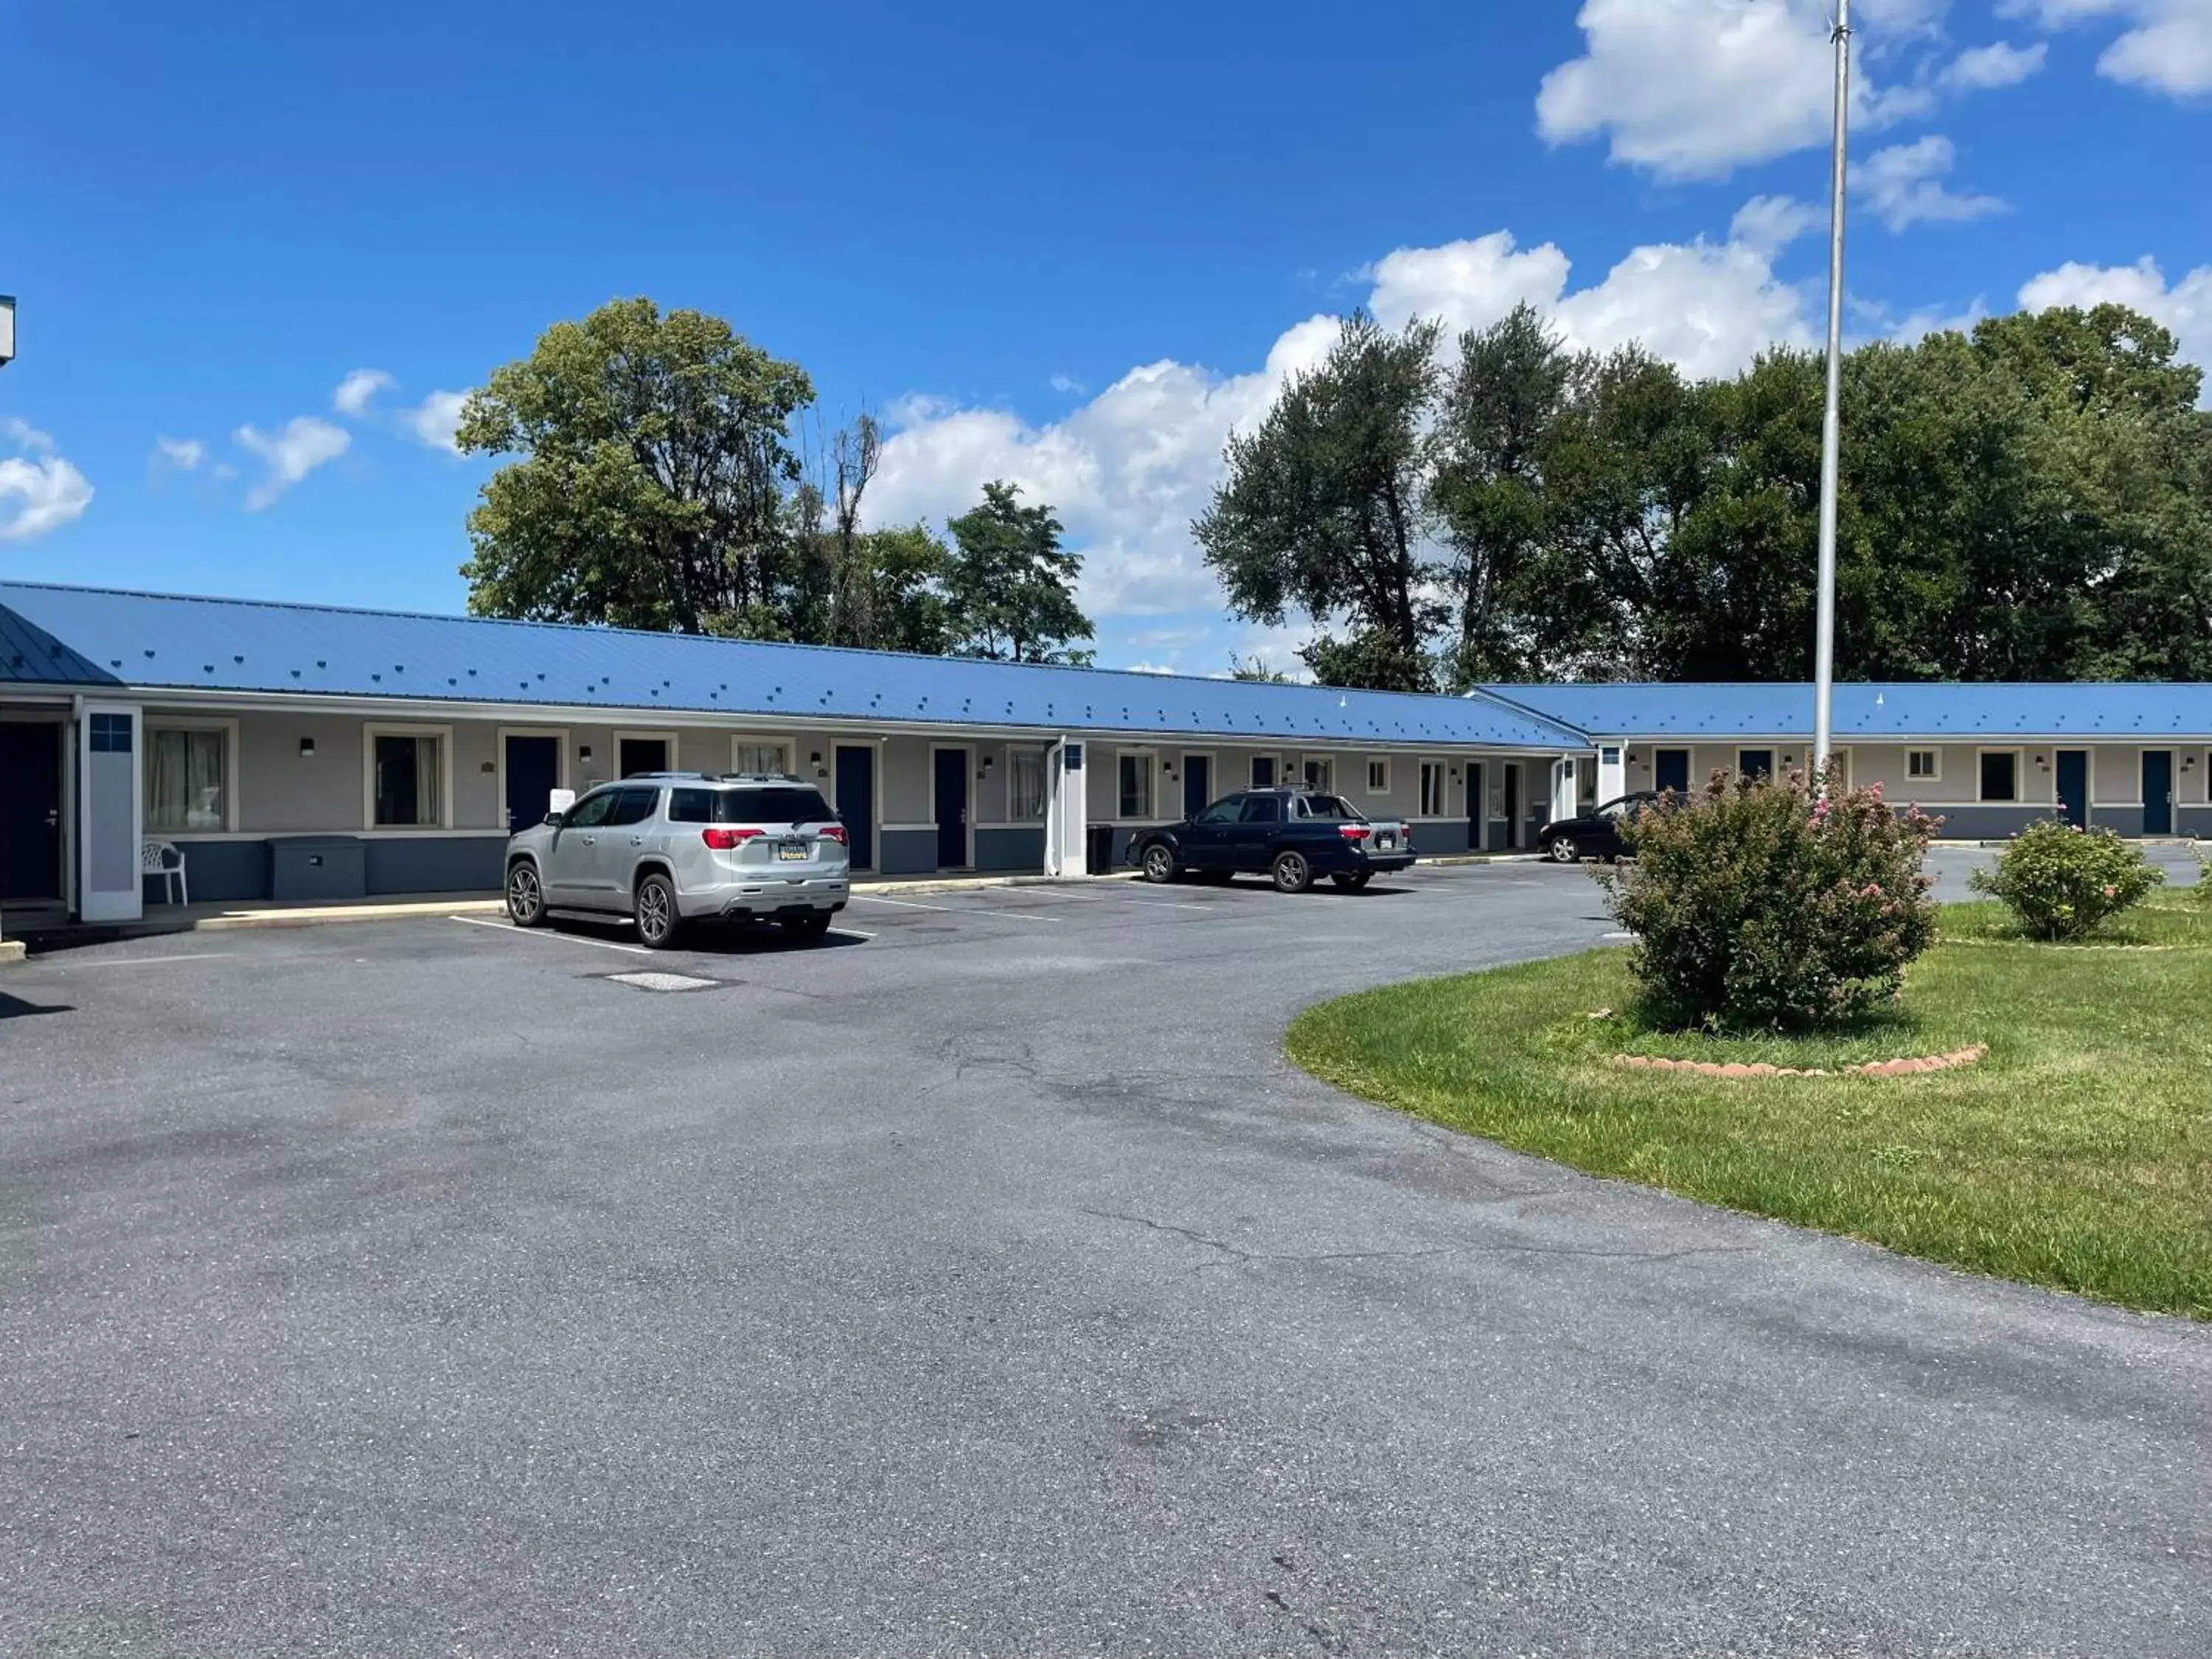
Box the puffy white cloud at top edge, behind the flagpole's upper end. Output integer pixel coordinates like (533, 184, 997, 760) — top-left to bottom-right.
(1535, 0, 1949, 179)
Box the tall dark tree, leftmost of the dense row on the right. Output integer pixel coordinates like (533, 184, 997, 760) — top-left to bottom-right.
(1192, 312, 1447, 690)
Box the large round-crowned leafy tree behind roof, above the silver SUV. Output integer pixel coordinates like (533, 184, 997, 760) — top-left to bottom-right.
(456, 299, 814, 637)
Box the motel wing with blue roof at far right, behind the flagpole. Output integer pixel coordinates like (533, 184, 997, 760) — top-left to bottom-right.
(1484, 684, 2212, 841)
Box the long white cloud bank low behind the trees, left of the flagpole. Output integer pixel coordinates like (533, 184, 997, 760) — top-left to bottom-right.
(867, 221, 1812, 624)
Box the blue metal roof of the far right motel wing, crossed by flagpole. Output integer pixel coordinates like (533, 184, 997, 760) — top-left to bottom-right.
(1484, 681, 2212, 741)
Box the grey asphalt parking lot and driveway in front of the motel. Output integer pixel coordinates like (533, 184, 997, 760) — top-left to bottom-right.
(0, 865, 2212, 1659)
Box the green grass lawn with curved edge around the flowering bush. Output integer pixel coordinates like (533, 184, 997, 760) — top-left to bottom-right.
(1287, 894, 2212, 1318)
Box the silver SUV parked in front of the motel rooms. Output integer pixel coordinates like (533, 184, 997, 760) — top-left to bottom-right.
(507, 772, 852, 951)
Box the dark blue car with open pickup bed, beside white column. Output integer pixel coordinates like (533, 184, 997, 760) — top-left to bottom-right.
(1128, 790, 1413, 894)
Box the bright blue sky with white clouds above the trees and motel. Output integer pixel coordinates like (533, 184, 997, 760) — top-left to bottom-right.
(0, 0, 2212, 672)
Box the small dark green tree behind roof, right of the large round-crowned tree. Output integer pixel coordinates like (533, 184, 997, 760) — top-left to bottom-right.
(945, 482, 1093, 664)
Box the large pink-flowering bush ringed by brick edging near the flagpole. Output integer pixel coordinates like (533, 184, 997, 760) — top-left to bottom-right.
(1597, 772, 1940, 1029)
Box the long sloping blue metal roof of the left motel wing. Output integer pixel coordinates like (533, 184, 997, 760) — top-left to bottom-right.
(0, 582, 1586, 754)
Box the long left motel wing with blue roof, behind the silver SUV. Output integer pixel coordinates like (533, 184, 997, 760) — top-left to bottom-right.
(0, 582, 1588, 933)
